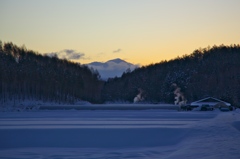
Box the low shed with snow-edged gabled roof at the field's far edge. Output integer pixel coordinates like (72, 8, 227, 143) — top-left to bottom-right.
(191, 97, 231, 107)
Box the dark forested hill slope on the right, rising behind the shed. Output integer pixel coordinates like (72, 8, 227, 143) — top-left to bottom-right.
(102, 45, 240, 105)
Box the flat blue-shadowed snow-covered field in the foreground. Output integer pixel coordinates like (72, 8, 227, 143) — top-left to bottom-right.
(0, 107, 240, 159)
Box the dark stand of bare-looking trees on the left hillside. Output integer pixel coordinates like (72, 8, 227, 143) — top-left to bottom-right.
(0, 42, 103, 103)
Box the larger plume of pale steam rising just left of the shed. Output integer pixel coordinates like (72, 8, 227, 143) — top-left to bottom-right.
(172, 83, 187, 106)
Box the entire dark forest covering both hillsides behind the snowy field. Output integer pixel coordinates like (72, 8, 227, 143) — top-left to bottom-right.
(0, 42, 240, 106)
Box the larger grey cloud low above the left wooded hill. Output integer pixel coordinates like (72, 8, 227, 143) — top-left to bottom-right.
(47, 49, 85, 60)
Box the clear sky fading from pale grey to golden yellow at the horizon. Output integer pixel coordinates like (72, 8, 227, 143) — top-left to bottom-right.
(0, 0, 240, 65)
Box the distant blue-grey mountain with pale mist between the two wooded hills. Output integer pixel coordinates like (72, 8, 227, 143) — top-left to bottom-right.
(87, 58, 139, 80)
